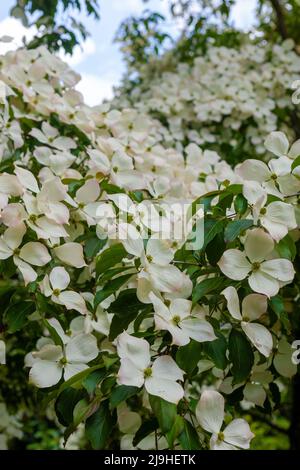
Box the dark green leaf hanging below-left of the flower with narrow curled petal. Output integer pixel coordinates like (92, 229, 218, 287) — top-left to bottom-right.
(228, 329, 254, 384)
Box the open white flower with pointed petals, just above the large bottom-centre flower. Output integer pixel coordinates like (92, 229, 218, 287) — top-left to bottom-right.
(149, 293, 217, 346)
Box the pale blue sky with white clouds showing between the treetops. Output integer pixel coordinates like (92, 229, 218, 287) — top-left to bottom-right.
(0, 0, 256, 105)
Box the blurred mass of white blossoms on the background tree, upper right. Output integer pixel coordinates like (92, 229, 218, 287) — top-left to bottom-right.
(114, 40, 300, 161)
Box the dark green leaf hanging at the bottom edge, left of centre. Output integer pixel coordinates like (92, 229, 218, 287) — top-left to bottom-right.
(85, 400, 116, 449)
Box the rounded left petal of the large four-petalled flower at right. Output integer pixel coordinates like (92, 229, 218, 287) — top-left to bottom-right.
(218, 249, 251, 281)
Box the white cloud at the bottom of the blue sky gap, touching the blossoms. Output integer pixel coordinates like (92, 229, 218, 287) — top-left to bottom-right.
(76, 73, 116, 106)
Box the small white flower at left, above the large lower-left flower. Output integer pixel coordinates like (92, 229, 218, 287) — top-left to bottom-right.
(40, 266, 88, 315)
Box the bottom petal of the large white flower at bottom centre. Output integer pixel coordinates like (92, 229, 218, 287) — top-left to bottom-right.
(145, 377, 184, 404)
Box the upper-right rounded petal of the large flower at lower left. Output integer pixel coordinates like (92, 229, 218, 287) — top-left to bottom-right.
(66, 333, 99, 363)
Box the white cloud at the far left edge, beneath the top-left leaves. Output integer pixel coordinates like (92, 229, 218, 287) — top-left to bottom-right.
(0, 17, 37, 54)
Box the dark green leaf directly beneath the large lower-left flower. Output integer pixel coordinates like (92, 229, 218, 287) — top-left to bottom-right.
(55, 387, 85, 426)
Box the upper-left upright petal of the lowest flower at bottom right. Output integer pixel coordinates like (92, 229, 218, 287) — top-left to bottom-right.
(196, 390, 225, 434)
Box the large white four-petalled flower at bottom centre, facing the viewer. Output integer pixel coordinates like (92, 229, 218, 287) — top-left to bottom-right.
(117, 332, 184, 403)
